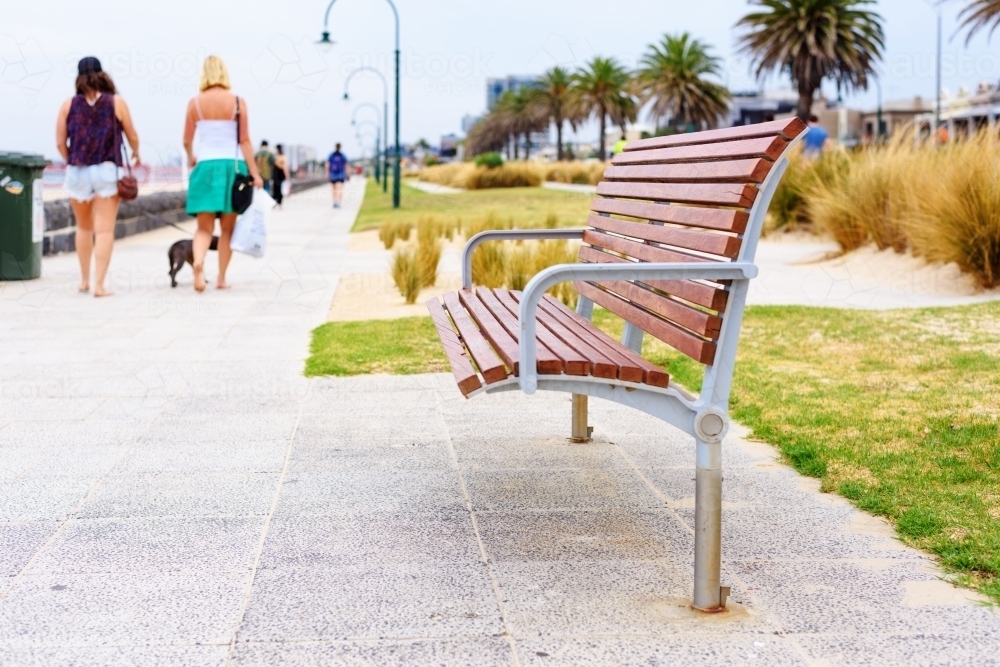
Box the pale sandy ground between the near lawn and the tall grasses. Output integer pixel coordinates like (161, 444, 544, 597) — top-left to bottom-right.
(330, 230, 1000, 321)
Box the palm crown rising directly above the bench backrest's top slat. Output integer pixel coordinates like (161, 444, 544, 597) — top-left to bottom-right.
(636, 32, 732, 129)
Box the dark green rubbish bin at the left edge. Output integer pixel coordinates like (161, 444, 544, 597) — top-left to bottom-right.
(0, 152, 49, 280)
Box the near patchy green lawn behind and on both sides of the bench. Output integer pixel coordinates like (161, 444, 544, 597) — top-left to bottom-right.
(306, 302, 1000, 601)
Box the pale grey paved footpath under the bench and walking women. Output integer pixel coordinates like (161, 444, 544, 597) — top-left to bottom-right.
(0, 184, 1000, 667)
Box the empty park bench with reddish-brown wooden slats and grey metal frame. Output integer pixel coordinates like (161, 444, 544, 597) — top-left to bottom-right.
(427, 118, 806, 611)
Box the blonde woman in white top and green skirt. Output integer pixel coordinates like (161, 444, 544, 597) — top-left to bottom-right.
(184, 56, 264, 292)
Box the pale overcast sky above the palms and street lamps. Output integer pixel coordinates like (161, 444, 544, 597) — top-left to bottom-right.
(0, 0, 1000, 164)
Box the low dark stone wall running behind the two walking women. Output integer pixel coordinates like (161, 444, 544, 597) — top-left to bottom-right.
(42, 178, 326, 255)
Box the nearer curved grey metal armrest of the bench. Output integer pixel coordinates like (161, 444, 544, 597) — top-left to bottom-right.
(516, 262, 758, 394)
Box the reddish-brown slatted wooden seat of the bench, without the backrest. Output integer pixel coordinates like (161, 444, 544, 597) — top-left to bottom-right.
(427, 287, 670, 397)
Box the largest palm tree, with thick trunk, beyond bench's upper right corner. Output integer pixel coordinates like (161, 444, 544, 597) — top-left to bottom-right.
(736, 0, 885, 120)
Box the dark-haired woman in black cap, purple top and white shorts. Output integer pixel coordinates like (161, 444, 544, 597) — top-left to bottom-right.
(56, 57, 141, 296)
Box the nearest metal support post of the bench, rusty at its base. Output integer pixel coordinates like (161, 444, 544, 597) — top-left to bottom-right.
(694, 438, 728, 612)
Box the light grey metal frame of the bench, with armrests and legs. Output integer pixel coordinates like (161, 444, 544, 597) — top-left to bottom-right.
(462, 138, 804, 612)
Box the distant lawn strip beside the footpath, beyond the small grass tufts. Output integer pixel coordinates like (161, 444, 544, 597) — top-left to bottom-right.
(351, 180, 593, 232)
